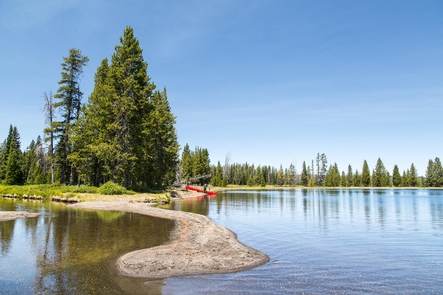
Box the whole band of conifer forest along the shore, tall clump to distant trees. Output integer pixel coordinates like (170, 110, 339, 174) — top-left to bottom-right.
(0, 27, 443, 200)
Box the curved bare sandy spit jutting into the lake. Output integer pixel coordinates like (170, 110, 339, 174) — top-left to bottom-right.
(69, 202, 269, 279)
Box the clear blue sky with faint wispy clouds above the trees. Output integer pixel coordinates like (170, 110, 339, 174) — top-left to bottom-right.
(0, 0, 443, 175)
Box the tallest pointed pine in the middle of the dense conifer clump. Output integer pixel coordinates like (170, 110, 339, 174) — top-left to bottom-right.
(107, 27, 155, 187)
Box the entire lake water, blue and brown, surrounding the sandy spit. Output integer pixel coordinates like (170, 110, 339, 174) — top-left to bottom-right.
(0, 189, 443, 294)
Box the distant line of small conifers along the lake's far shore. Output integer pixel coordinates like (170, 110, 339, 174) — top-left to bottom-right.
(182, 154, 443, 187)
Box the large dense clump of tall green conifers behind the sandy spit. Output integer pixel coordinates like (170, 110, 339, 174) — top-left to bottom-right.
(69, 27, 179, 189)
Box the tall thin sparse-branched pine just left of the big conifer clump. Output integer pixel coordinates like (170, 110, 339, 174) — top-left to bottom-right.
(51, 48, 89, 184)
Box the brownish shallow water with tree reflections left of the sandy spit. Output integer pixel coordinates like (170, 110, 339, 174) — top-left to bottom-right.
(0, 199, 175, 294)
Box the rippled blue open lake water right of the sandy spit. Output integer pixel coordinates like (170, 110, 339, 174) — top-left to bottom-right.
(162, 189, 443, 294)
